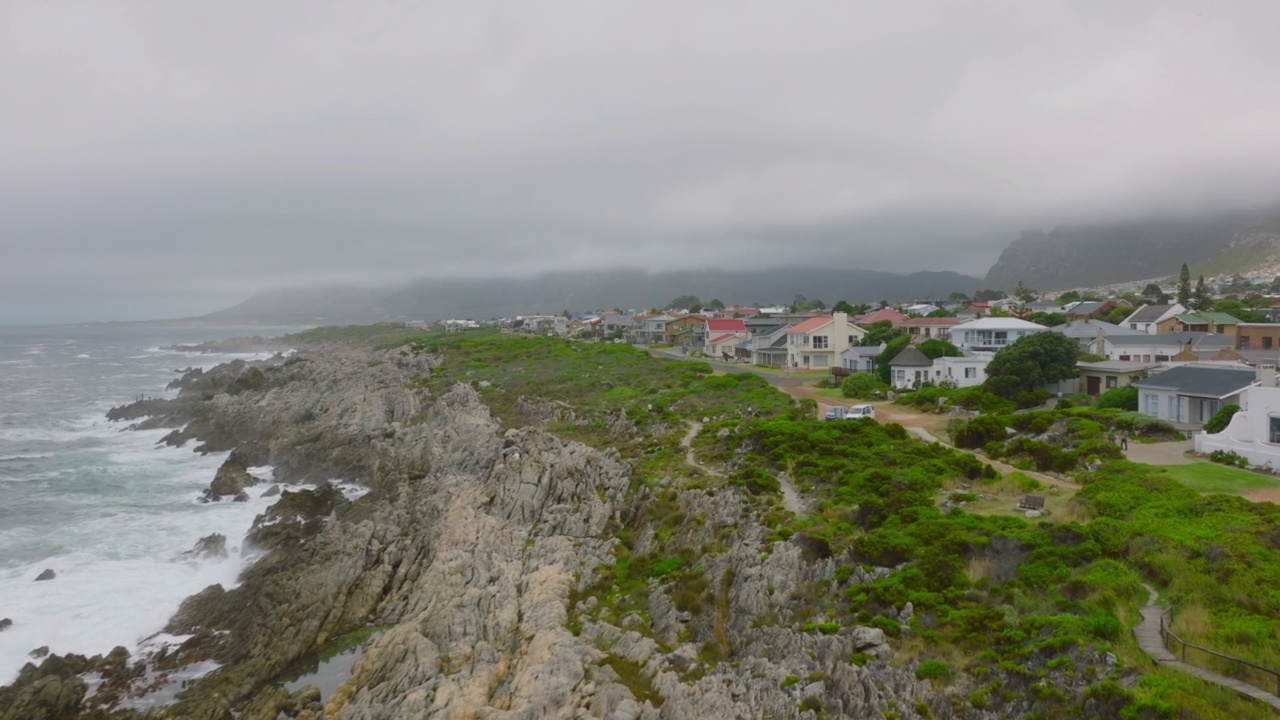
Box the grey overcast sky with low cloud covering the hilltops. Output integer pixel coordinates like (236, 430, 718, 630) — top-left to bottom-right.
(0, 0, 1280, 322)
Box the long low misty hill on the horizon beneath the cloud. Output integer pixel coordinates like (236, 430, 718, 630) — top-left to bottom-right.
(200, 268, 979, 324)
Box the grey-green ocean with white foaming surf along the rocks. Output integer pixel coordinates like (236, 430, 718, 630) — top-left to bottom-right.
(0, 325, 296, 684)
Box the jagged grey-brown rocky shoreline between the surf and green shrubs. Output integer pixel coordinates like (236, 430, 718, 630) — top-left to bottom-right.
(0, 338, 1136, 720)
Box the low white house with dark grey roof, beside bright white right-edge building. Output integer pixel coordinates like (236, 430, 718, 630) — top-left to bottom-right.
(1133, 365, 1258, 428)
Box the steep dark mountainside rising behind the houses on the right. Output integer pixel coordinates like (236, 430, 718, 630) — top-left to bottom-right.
(984, 209, 1277, 291)
